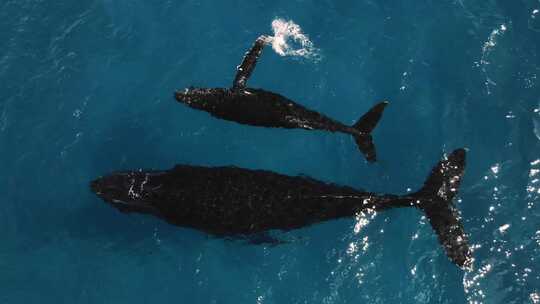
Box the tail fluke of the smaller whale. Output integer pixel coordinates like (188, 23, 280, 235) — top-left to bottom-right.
(352, 101, 388, 163)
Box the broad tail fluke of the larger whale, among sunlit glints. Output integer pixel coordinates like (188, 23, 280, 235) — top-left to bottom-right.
(412, 149, 472, 267)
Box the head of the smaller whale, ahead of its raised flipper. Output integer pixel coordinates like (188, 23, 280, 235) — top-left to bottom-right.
(174, 87, 228, 112)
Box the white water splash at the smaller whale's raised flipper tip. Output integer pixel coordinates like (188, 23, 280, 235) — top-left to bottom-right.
(266, 18, 321, 61)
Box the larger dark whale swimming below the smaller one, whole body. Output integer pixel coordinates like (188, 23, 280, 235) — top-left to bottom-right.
(90, 149, 471, 267)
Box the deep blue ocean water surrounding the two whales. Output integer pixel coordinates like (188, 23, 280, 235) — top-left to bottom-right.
(0, 0, 540, 304)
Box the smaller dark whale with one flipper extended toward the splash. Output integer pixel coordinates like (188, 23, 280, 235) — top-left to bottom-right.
(175, 36, 388, 162)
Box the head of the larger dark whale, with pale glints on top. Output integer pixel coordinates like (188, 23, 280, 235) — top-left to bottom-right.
(90, 172, 157, 214)
